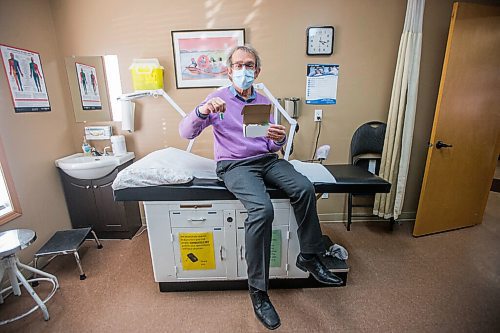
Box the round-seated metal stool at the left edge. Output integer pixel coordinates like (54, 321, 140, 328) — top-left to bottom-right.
(0, 229, 59, 325)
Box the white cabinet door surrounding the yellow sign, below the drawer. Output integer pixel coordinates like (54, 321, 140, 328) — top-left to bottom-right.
(172, 227, 227, 280)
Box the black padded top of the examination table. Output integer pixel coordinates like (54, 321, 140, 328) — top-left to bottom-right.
(114, 164, 391, 201)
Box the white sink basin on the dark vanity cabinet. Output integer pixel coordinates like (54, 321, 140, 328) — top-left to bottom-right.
(56, 153, 135, 179)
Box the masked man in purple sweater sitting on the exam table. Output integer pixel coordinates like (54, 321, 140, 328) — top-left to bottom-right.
(179, 46, 342, 329)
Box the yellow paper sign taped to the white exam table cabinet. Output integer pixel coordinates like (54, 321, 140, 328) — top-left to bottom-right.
(179, 232, 215, 271)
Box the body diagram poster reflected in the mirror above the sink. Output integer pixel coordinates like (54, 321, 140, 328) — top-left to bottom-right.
(75, 62, 102, 110)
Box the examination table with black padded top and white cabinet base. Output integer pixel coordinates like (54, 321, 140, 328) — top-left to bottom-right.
(114, 165, 391, 291)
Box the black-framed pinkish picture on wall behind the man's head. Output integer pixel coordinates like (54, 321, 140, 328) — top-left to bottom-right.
(172, 29, 245, 88)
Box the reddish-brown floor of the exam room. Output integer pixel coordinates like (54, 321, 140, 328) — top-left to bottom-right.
(0, 192, 500, 332)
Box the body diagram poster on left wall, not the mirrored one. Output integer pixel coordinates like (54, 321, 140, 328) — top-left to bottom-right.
(0, 44, 50, 112)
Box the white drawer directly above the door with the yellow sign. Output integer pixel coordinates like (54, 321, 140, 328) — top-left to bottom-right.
(170, 209, 224, 228)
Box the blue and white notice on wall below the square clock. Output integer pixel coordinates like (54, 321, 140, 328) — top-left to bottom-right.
(306, 64, 339, 104)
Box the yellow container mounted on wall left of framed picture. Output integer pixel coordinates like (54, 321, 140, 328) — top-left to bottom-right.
(129, 58, 163, 90)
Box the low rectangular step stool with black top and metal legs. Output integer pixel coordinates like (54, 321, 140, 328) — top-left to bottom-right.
(35, 227, 102, 280)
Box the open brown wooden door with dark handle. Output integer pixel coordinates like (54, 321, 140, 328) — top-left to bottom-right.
(413, 3, 500, 236)
